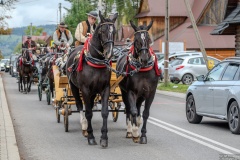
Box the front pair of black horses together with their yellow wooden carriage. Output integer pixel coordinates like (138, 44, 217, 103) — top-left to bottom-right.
(31, 13, 158, 148)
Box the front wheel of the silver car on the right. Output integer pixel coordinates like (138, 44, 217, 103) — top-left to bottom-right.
(186, 95, 202, 123)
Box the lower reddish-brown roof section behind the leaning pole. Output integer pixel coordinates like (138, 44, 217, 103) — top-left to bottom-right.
(153, 22, 235, 50)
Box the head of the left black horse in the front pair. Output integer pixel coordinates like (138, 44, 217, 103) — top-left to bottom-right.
(92, 11, 118, 60)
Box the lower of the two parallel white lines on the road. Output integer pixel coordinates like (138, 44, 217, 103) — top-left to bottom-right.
(148, 120, 233, 154)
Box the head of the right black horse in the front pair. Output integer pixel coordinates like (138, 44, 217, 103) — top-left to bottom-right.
(130, 21, 153, 67)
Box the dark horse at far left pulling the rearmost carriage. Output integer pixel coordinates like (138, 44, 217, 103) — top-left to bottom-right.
(19, 48, 33, 93)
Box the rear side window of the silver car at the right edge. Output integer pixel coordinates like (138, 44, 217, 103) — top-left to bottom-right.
(222, 64, 239, 81)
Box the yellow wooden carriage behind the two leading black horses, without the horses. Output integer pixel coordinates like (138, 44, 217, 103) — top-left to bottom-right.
(53, 59, 124, 132)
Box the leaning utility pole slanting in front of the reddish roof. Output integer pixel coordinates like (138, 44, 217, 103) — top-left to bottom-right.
(184, 0, 210, 70)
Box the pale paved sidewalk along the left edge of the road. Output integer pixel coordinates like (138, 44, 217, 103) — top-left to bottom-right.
(0, 75, 20, 160)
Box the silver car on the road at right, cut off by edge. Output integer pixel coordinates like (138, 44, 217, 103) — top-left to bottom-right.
(186, 58, 240, 134)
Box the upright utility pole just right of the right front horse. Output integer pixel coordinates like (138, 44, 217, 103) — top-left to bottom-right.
(164, 0, 169, 86)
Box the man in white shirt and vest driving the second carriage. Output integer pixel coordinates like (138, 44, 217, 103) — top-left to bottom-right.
(53, 22, 73, 48)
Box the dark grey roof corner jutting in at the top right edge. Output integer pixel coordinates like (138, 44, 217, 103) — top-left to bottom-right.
(211, 4, 240, 35)
